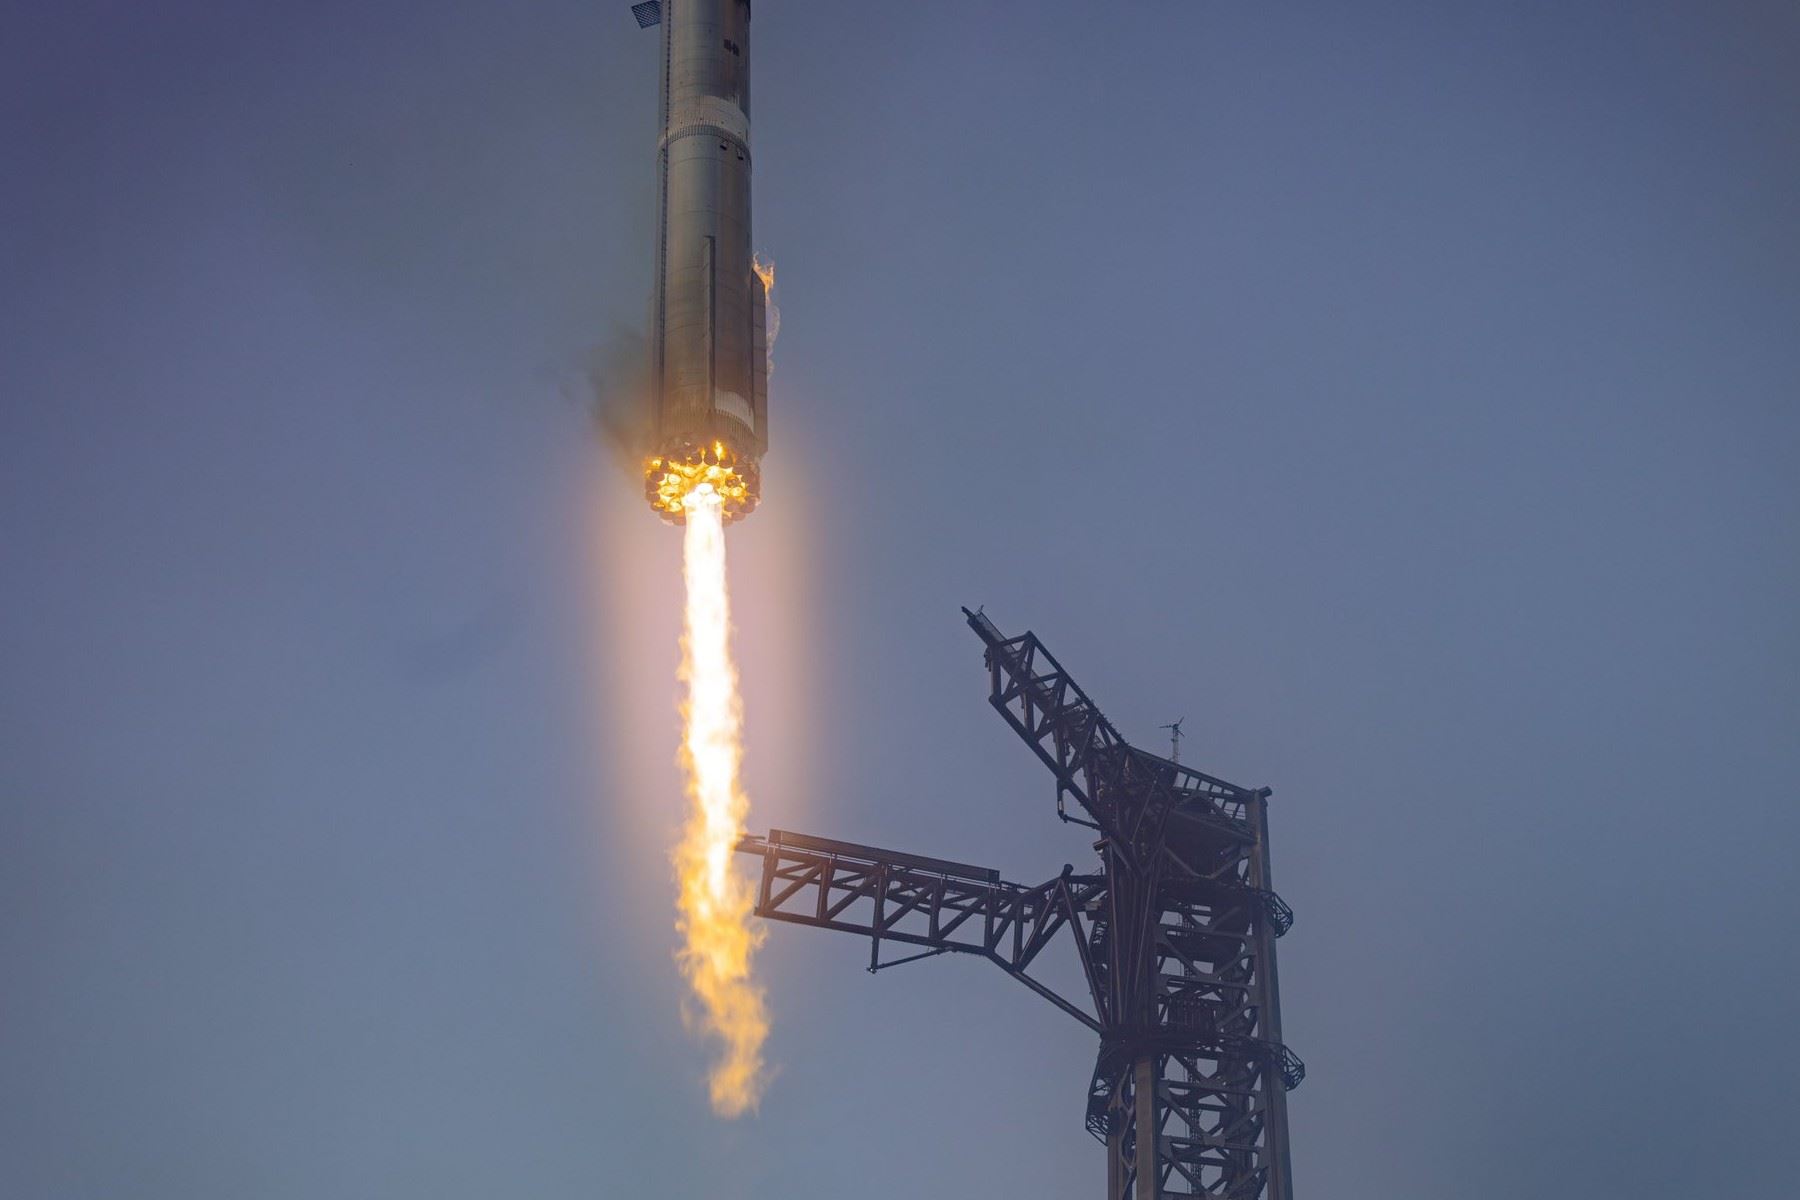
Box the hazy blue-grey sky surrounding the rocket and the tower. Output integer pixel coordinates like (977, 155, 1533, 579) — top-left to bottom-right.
(0, 0, 1800, 1200)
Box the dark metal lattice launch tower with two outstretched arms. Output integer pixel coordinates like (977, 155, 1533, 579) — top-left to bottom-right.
(738, 608, 1305, 1200)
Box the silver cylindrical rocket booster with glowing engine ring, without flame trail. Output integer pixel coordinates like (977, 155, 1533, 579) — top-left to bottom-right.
(632, 0, 769, 524)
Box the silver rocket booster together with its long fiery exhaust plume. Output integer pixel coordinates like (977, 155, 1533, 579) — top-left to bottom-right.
(632, 0, 772, 1117)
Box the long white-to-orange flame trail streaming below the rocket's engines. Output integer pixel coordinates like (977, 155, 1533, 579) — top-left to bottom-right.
(675, 484, 769, 1117)
